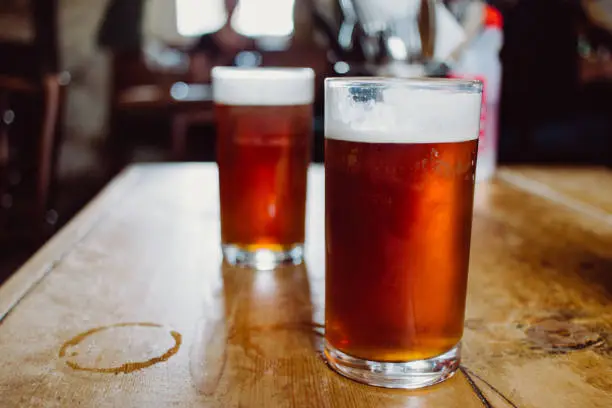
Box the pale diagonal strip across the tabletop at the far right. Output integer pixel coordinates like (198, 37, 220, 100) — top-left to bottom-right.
(498, 172, 612, 224)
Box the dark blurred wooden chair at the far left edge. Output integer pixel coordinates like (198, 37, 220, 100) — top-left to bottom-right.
(0, 0, 69, 240)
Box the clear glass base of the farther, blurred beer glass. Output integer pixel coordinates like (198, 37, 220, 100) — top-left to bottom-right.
(221, 244, 304, 270)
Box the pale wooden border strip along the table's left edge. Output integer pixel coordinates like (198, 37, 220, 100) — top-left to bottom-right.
(0, 167, 141, 325)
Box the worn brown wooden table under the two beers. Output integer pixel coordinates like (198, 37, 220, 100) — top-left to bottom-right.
(0, 164, 612, 408)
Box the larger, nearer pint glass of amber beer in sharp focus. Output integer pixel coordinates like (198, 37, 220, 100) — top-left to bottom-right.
(325, 78, 482, 388)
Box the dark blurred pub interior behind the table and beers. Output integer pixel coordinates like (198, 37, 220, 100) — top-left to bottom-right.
(0, 0, 612, 282)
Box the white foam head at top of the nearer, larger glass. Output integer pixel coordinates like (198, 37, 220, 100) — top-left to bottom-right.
(325, 78, 482, 143)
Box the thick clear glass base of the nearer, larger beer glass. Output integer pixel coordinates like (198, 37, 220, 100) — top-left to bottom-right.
(324, 342, 461, 389)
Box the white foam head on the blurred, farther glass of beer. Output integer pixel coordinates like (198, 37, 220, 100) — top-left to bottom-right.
(212, 67, 314, 106)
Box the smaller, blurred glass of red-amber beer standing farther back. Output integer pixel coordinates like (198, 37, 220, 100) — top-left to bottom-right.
(212, 67, 314, 269)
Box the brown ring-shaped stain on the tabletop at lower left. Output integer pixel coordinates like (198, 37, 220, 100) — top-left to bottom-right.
(59, 322, 182, 374)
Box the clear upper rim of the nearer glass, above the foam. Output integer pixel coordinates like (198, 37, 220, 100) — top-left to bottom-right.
(325, 76, 483, 93)
